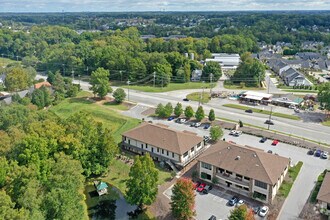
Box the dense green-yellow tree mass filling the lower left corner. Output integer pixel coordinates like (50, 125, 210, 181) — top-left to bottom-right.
(0, 104, 118, 219)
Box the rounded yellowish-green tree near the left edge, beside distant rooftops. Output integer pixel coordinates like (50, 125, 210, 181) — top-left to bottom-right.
(5, 67, 30, 92)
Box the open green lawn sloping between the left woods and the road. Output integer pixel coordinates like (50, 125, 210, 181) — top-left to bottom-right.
(50, 92, 140, 143)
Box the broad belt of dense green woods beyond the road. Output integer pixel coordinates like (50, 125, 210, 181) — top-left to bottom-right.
(0, 26, 257, 86)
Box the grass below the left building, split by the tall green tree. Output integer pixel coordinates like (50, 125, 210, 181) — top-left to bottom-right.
(102, 160, 171, 194)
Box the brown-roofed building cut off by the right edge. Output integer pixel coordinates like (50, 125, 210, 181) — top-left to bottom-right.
(316, 172, 330, 216)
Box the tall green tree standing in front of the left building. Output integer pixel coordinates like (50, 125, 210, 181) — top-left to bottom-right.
(126, 153, 158, 208)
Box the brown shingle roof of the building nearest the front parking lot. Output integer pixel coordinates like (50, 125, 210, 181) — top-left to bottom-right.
(198, 141, 289, 185)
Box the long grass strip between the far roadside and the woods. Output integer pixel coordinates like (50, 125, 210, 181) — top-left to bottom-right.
(120, 82, 216, 92)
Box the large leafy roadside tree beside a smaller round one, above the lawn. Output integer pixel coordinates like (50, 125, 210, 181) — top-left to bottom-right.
(90, 68, 112, 98)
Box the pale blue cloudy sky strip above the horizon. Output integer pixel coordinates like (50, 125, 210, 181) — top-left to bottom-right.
(0, 0, 330, 12)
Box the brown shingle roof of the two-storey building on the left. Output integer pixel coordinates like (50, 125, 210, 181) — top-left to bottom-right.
(123, 123, 203, 155)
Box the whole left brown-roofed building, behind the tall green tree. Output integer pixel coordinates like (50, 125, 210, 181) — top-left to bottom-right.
(122, 123, 205, 168)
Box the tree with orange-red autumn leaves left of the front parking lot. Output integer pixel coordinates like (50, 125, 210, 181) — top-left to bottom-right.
(171, 178, 196, 220)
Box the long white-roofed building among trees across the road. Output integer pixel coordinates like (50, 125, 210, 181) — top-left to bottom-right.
(205, 53, 240, 70)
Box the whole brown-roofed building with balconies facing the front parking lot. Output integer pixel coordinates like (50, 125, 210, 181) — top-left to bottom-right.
(197, 141, 290, 203)
